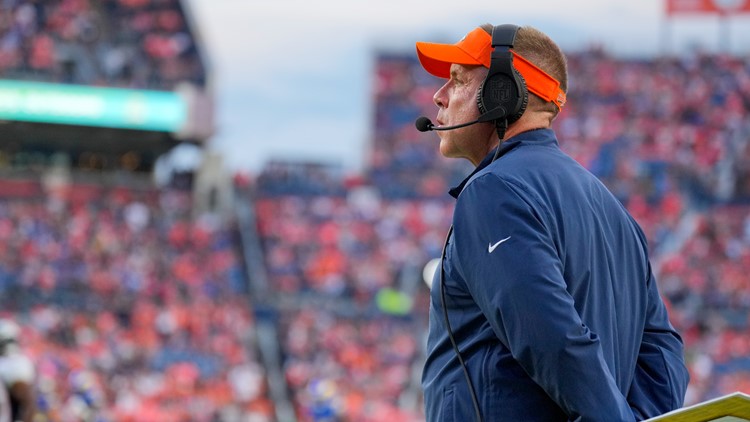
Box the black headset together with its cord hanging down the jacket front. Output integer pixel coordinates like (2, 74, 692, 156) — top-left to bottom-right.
(439, 24, 529, 422)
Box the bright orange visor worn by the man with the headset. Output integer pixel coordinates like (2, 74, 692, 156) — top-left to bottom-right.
(417, 28, 566, 109)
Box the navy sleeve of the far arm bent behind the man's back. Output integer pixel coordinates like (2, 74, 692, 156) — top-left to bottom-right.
(628, 267, 690, 420)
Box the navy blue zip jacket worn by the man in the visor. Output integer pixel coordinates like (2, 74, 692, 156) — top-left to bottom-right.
(422, 129, 688, 422)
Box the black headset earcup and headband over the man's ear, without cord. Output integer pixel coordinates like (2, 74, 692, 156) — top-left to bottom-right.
(477, 24, 529, 139)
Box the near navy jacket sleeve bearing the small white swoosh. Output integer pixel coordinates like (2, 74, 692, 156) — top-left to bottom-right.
(454, 174, 634, 422)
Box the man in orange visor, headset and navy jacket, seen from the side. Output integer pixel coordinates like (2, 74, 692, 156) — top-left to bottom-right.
(417, 25, 688, 422)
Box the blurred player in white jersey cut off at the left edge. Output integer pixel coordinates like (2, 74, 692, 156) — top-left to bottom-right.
(0, 319, 36, 422)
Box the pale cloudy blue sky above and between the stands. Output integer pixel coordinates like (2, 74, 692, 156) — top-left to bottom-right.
(185, 0, 750, 174)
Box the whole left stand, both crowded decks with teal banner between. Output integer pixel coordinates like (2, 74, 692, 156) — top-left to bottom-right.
(0, 0, 277, 422)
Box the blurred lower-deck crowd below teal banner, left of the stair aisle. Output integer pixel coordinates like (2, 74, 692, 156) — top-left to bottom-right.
(0, 185, 274, 421)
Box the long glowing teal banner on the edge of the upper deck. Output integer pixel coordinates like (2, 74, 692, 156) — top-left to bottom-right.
(0, 80, 187, 132)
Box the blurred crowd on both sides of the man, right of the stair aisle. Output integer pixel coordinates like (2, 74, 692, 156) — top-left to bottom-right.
(255, 48, 750, 421)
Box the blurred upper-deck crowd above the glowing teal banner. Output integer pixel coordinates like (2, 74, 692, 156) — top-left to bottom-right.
(0, 0, 206, 90)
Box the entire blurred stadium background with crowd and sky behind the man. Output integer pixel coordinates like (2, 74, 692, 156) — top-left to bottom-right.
(0, 0, 750, 422)
